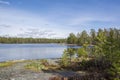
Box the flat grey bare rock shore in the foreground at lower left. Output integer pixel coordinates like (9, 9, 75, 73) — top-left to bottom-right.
(0, 59, 82, 80)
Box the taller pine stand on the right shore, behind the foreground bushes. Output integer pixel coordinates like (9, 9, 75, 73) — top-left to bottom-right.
(67, 28, 120, 45)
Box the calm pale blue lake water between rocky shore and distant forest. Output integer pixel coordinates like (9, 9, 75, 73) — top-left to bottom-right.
(0, 44, 80, 61)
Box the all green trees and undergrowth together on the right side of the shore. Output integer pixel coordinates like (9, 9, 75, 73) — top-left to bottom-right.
(61, 28, 120, 80)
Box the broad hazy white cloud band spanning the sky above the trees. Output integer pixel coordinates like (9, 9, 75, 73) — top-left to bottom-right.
(0, 4, 119, 38)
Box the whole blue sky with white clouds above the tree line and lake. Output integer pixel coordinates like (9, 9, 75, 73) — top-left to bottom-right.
(0, 0, 120, 38)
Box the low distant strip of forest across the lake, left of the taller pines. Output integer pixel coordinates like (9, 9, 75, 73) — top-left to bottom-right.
(0, 37, 65, 44)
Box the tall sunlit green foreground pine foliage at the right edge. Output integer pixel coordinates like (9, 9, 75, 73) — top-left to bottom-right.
(91, 29, 120, 77)
